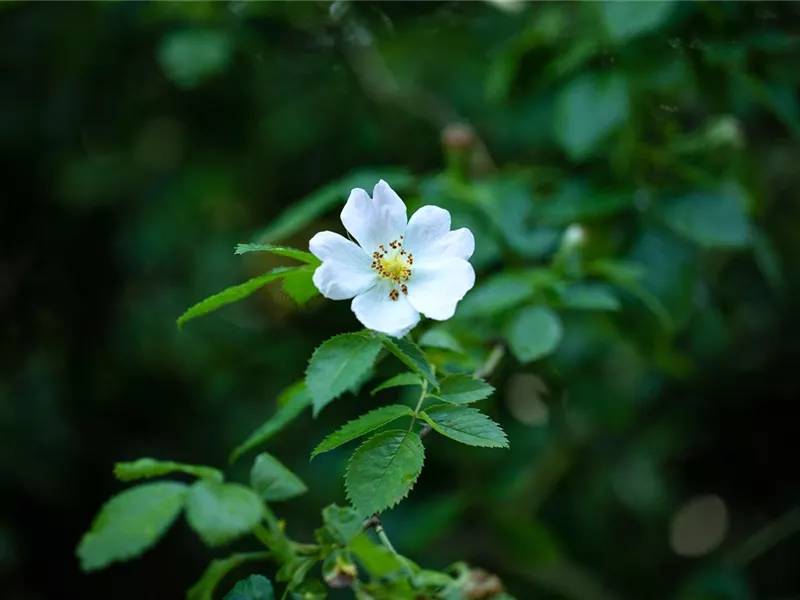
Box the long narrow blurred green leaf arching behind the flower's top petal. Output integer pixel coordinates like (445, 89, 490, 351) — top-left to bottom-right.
(256, 167, 414, 243)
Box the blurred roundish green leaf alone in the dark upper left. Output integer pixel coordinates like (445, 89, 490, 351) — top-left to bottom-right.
(158, 29, 233, 89)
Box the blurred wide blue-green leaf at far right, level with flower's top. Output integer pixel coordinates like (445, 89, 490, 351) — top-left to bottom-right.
(660, 190, 752, 248)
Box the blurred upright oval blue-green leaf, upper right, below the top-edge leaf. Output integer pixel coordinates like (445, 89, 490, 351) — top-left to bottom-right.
(554, 73, 635, 160)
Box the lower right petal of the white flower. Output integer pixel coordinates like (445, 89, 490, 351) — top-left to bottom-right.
(407, 258, 475, 321)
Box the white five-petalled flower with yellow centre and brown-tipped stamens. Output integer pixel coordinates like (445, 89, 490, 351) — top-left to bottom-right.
(308, 180, 475, 337)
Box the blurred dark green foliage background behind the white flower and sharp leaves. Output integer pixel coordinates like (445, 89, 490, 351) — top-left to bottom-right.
(0, 0, 800, 600)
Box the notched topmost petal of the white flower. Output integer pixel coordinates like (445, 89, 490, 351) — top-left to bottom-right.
(341, 180, 407, 254)
